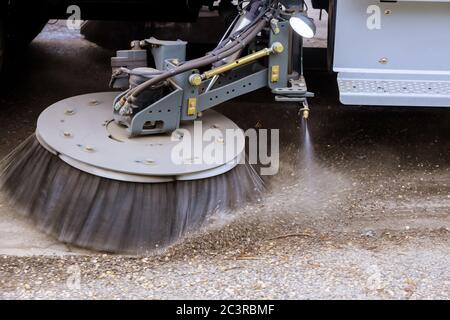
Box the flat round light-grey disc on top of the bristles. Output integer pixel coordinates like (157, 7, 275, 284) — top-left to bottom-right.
(36, 92, 245, 183)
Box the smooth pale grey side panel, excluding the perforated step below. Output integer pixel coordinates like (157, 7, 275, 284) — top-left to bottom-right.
(334, 0, 450, 74)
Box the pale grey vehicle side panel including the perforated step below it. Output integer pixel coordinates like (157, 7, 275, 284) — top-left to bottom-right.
(334, 0, 450, 107)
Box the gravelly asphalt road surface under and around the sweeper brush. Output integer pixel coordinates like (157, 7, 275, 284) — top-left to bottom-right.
(0, 19, 450, 299)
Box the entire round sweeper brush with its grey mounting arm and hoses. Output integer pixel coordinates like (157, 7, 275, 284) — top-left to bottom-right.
(0, 0, 314, 253)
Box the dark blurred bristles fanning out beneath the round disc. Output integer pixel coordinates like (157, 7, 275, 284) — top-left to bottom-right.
(0, 135, 264, 253)
